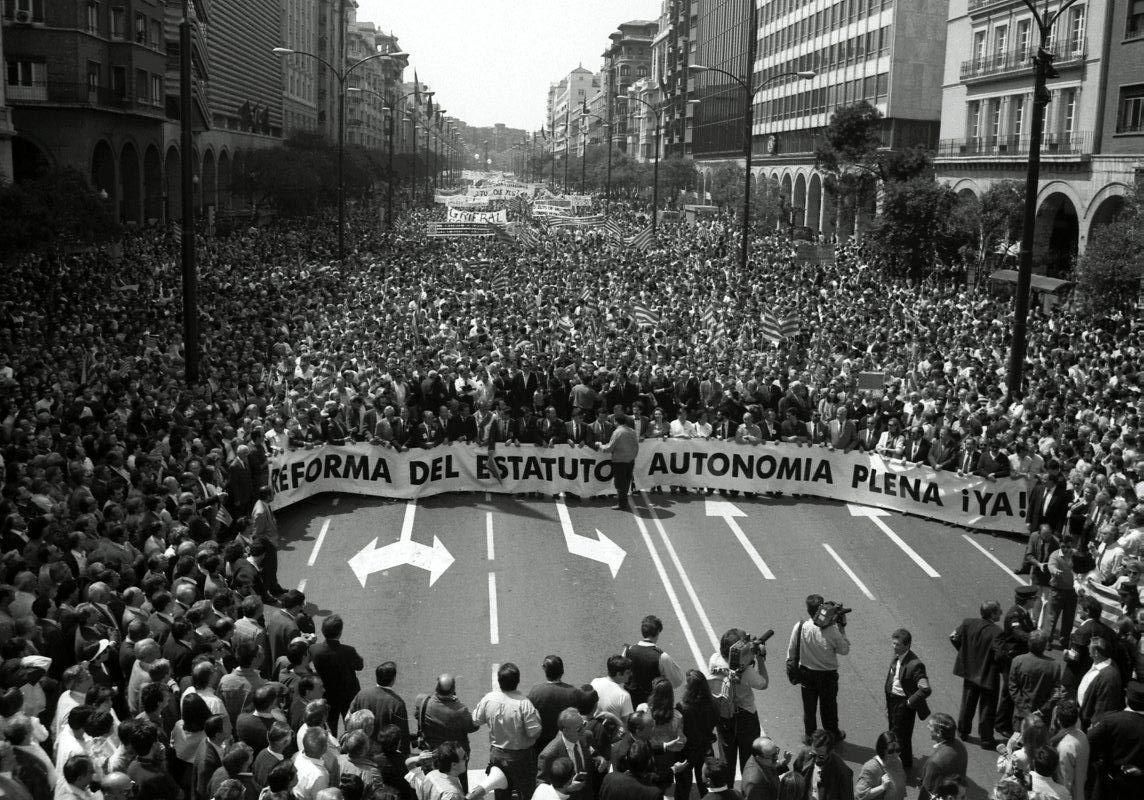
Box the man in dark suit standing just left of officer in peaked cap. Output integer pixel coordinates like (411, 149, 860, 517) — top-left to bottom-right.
(950, 600, 1001, 750)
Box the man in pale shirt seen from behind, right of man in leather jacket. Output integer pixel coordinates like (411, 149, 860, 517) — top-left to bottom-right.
(472, 662, 541, 800)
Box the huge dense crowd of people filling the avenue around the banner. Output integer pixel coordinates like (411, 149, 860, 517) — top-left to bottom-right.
(0, 192, 1144, 800)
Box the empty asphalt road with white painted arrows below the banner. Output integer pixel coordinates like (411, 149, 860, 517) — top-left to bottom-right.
(279, 490, 1023, 798)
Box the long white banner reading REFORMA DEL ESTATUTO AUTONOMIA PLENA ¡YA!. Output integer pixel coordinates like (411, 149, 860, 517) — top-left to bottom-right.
(270, 439, 1028, 532)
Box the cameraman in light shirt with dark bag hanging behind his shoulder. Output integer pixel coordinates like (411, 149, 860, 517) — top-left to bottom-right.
(787, 594, 850, 743)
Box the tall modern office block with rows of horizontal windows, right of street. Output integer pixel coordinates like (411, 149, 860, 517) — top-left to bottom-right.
(692, 0, 956, 238)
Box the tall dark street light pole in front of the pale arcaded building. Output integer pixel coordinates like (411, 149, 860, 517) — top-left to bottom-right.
(1006, 0, 1077, 399)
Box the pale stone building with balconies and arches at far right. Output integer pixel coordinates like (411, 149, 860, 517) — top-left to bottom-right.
(936, 0, 1144, 275)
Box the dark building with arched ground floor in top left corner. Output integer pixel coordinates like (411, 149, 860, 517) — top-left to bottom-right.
(0, 0, 173, 218)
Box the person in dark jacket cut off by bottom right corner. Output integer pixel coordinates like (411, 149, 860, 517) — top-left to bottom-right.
(1088, 681, 1144, 800)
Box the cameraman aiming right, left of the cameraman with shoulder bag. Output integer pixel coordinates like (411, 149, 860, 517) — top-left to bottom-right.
(707, 628, 774, 769)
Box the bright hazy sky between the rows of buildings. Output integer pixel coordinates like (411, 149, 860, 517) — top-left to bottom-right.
(357, 0, 661, 130)
